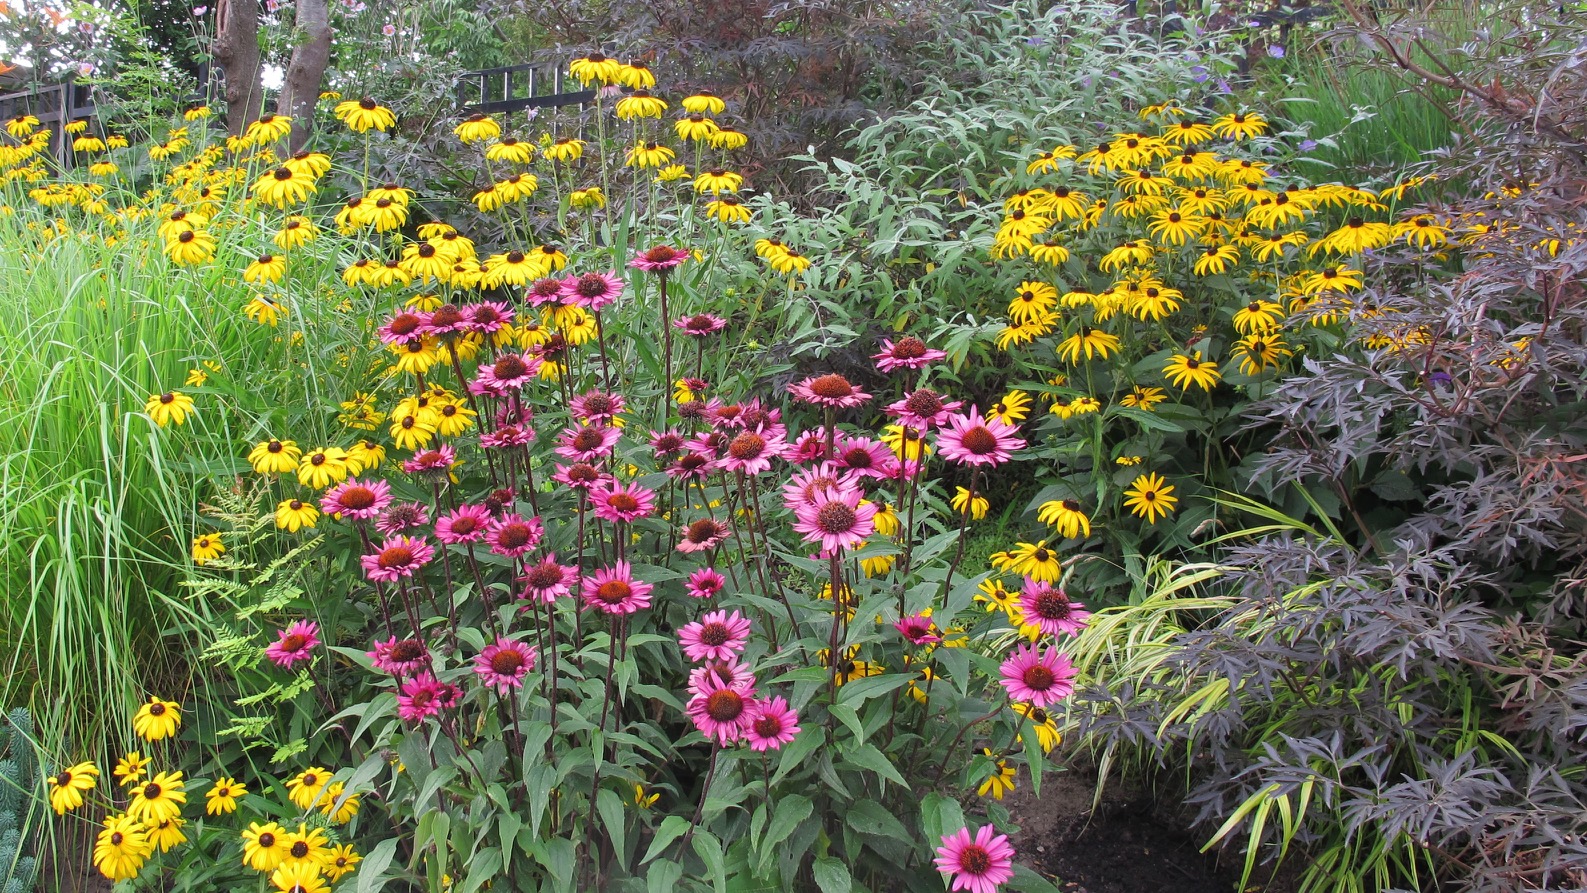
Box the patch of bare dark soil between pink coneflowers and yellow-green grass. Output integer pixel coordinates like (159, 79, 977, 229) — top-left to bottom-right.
(1005, 771, 1282, 893)
